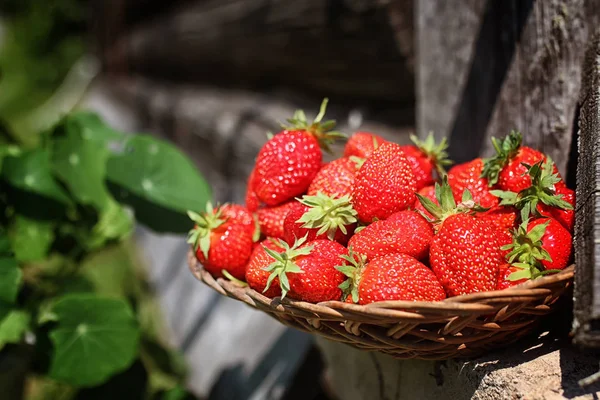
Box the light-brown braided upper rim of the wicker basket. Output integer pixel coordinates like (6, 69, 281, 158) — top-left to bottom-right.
(188, 250, 575, 317)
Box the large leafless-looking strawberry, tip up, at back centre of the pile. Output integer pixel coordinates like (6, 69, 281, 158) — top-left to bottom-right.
(352, 142, 416, 223)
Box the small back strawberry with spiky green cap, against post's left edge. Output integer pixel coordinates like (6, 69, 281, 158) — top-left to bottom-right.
(402, 134, 452, 190)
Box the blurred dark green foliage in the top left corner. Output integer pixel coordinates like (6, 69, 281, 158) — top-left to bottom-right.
(0, 0, 87, 130)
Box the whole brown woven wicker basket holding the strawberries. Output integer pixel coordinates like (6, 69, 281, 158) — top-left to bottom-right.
(188, 251, 574, 360)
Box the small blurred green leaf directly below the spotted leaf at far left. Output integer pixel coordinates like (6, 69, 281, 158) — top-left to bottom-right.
(9, 215, 54, 262)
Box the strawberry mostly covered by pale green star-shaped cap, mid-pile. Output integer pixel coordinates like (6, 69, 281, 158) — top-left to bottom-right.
(283, 193, 357, 245)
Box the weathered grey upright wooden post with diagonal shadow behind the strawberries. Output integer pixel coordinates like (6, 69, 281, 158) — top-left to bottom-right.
(417, 0, 600, 173)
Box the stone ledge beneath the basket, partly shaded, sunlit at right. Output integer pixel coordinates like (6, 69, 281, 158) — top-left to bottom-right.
(317, 334, 600, 400)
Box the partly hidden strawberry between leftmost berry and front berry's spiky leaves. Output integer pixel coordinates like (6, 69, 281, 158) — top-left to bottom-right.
(246, 239, 284, 298)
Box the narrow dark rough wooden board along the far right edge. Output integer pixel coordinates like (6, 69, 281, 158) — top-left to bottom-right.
(574, 30, 600, 347)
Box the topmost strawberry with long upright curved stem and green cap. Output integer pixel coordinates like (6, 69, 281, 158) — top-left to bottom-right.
(254, 99, 342, 206)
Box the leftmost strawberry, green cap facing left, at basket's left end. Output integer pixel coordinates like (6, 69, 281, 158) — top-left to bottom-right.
(188, 203, 255, 279)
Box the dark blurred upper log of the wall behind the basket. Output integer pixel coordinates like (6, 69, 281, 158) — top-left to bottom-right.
(105, 0, 414, 104)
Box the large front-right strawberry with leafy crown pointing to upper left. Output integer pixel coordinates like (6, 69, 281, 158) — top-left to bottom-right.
(419, 178, 504, 296)
